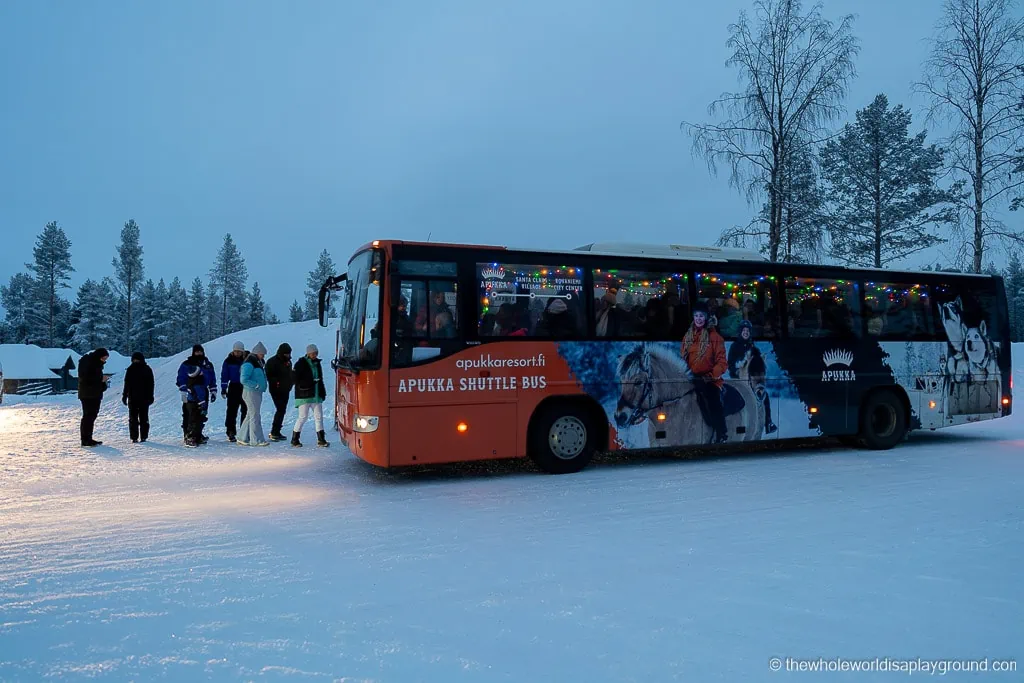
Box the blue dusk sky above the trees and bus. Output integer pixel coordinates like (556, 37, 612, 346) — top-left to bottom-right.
(0, 0, 1016, 317)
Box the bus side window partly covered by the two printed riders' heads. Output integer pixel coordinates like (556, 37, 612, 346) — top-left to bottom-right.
(696, 272, 778, 340)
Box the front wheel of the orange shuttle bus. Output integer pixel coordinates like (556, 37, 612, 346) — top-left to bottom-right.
(527, 401, 598, 474)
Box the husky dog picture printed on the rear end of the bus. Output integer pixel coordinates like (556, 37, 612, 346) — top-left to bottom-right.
(939, 297, 1002, 421)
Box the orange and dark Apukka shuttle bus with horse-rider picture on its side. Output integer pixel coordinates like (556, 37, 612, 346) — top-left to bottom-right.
(321, 241, 1013, 472)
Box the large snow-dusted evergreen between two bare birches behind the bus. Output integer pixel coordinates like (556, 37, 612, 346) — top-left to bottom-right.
(821, 95, 961, 268)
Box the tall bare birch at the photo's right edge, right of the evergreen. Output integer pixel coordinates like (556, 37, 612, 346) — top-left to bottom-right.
(915, 0, 1024, 272)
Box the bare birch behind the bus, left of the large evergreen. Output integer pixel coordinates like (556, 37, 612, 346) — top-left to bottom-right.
(682, 0, 859, 261)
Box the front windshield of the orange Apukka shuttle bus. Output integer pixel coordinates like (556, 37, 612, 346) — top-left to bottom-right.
(339, 249, 382, 367)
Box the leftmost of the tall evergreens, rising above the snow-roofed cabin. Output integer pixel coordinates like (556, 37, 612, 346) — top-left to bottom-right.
(26, 221, 75, 347)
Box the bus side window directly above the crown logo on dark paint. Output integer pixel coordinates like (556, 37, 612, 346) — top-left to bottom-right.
(785, 278, 861, 339)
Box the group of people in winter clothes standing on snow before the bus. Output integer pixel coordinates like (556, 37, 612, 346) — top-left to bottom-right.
(78, 341, 330, 447)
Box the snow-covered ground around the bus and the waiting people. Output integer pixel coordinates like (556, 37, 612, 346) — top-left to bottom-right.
(0, 339, 1024, 681)
